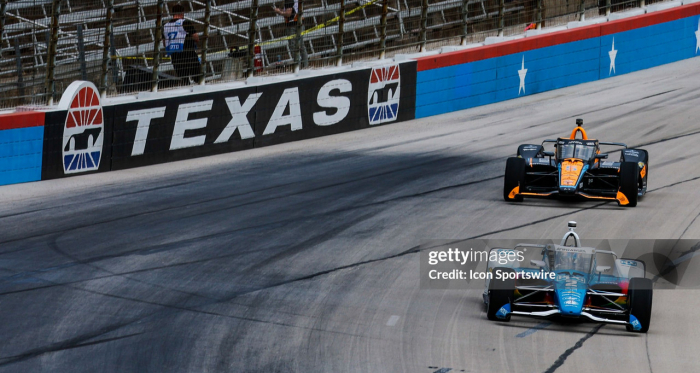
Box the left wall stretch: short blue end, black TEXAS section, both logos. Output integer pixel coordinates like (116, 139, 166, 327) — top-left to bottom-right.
(0, 61, 416, 185)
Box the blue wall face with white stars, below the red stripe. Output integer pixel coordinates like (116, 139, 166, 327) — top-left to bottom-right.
(416, 15, 700, 118)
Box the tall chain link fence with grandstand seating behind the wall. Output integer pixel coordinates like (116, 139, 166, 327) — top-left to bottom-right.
(0, 0, 672, 110)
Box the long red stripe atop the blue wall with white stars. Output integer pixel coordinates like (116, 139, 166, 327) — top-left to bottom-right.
(416, 3, 700, 71)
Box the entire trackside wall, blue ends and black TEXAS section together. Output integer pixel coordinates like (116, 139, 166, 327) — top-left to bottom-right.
(0, 2, 700, 185)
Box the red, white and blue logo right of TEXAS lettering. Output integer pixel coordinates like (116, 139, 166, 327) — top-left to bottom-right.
(367, 65, 401, 125)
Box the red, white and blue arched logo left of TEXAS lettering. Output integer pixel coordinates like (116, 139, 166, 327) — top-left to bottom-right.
(58, 81, 104, 174)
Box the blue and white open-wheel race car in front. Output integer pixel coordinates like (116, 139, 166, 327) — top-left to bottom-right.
(483, 222, 653, 333)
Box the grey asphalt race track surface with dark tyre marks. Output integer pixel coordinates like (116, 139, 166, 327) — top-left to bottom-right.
(0, 59, 700, 373)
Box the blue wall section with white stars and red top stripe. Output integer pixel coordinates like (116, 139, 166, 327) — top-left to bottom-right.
(416, 4, 700, 118)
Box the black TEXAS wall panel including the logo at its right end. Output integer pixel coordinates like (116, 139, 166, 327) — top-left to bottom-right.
(89, 61, 416, 170)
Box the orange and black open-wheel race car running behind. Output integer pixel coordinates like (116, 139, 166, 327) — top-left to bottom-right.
(503, 119, 649, 207)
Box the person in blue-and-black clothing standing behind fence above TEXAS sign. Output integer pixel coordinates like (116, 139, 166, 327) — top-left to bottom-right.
(163, 3, 202, 84)
